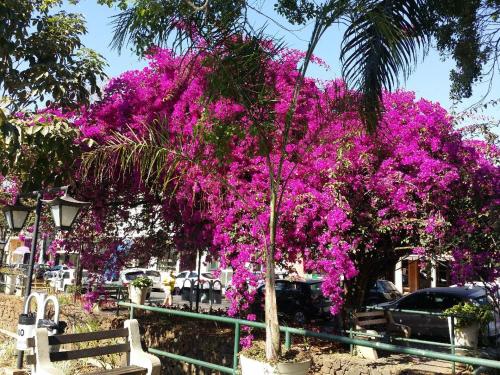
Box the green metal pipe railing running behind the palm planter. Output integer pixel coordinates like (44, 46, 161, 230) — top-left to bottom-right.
(119, 302, 500, 374)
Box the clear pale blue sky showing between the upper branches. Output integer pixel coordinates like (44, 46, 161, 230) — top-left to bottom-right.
(65, 0, 500, 133)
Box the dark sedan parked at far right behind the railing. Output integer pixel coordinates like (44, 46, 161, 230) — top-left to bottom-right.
(379, 287, 500, 342)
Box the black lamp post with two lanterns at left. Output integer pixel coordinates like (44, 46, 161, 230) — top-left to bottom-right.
(2, 187, 89, 369)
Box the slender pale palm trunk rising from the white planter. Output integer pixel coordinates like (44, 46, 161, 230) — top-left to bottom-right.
(265, 182, 281, 361)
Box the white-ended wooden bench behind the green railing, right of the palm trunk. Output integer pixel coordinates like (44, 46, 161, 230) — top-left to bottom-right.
(351, 310, 411, 360)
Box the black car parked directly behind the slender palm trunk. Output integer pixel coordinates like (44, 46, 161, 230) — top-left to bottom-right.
(251, 280, 331, 324)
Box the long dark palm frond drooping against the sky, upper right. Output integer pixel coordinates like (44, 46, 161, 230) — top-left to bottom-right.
(341, 0, 429, 132)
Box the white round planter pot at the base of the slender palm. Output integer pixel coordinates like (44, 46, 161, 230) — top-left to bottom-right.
(240, 355, 311, 375)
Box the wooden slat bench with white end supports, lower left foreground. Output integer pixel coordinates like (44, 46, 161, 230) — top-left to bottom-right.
(27, 319, 161, 375)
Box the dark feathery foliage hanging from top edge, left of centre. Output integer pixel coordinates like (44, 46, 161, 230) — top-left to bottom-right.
(110, 0, 249, 55)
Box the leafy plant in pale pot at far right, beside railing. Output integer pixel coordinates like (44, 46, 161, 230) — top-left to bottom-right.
(444, 302, 493, 349)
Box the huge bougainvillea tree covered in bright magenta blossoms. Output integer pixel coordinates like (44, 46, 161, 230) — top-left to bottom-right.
(78, 39, 499, 360)
